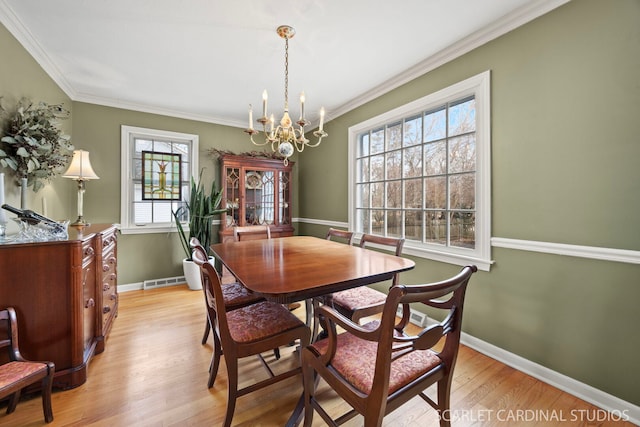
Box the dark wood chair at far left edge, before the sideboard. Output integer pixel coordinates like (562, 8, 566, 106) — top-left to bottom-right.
(0, 307, 56, 423)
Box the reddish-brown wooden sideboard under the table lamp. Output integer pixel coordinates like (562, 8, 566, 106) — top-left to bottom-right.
(0, 224, 118, 389)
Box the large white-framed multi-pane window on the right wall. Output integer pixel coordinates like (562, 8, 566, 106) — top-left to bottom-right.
(349, 72, 491, 270)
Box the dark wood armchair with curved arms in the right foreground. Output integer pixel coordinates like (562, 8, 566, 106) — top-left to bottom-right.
(302, 266, 477, 427)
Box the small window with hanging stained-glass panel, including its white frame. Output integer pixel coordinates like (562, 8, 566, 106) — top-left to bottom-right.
(120, 126, 198, 233)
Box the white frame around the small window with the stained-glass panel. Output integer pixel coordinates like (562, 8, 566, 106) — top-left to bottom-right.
(120, 125, 199, 234)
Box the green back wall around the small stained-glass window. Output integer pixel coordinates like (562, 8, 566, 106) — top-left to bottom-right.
(73, 102, 297, 285)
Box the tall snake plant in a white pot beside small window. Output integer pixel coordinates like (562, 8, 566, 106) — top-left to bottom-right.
(172, 171, 226, 289)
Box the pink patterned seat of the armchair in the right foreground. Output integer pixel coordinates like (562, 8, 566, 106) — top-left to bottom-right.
(312, 320, 442, 394)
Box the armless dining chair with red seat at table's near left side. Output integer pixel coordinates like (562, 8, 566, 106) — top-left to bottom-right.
(193, 247, 311, 427)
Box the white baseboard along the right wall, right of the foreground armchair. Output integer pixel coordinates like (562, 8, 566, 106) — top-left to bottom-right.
(460, 332, 640, 425)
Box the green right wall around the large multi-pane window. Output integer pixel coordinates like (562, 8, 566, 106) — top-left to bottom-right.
(298, 0, 640, 405)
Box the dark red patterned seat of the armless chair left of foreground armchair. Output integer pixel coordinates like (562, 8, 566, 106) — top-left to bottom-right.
(227, 301, 300, 343)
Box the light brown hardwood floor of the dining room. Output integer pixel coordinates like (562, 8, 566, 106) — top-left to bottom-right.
(0, 286, 632, 427)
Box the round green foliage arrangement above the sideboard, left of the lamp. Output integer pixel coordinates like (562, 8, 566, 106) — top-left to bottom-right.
(0, 98, 73, 191)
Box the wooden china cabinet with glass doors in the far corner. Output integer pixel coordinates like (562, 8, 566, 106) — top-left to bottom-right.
(220, 154, 293, 242)
